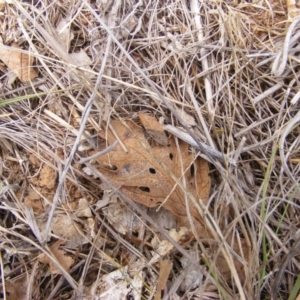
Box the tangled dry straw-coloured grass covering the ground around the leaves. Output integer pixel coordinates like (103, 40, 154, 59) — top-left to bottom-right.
(0, 0, 300, 299)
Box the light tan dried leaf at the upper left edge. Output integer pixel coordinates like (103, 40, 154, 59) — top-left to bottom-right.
(0, 43, 38, 82)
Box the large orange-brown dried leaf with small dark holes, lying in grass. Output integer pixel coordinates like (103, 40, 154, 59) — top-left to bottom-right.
(97, 120, 210, 230)
